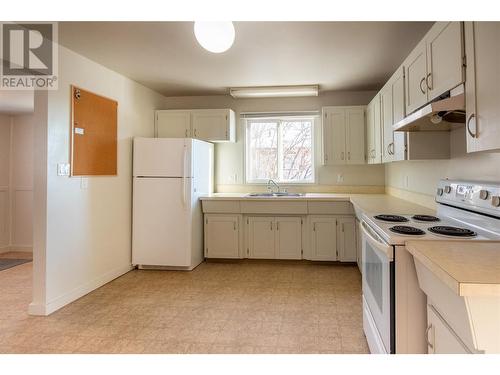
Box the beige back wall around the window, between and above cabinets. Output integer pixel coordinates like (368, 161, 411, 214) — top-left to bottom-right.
(164, 91, 384, 192)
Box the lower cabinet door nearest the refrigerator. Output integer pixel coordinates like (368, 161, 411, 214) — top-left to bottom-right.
(204, 215, 240, 258)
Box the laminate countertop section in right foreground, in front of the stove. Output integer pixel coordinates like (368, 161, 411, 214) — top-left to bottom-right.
(406, 240, 500, 297)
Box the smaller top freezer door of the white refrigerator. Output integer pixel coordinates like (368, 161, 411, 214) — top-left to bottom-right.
(134, 138, 192, 177)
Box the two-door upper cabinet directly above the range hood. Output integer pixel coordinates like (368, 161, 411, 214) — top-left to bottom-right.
(403, 22, 464, 114)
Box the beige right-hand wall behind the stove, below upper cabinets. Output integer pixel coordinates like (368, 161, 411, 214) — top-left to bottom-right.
(386, 128, 500, 196)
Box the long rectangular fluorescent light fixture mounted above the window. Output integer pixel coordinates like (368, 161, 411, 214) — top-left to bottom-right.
(229, 85, 318, 98)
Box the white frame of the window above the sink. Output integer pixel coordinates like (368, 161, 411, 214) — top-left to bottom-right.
(244, 115, 316, 186)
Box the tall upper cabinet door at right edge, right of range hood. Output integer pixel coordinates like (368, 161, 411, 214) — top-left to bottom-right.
(465, 22, 500, 152)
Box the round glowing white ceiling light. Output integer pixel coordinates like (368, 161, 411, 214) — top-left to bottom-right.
(194, 21, 234, 53)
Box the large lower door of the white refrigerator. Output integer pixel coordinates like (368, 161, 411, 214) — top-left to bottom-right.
(132, 178, 192, 267)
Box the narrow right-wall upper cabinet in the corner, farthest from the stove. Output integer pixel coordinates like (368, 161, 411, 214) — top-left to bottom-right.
(366, 94, 382, 164)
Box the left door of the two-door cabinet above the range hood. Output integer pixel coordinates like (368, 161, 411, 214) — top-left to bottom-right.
(404, 40, 427, 114)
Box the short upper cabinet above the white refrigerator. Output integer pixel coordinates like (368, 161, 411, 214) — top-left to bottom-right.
(155, 109, 236, 142)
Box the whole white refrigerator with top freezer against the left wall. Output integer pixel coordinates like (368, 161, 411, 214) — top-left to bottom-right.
(132, 138, 213, 270)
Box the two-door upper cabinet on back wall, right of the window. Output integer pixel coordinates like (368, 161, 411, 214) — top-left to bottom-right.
(322, 107, 365, 165)
